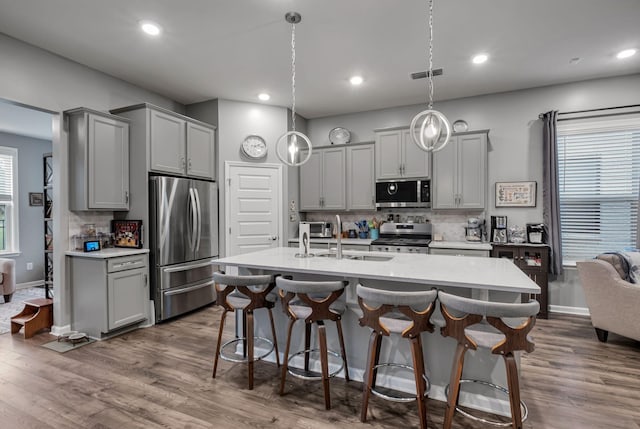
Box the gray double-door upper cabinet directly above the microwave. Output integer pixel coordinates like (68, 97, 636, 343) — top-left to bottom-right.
(375, 128, 431, 180)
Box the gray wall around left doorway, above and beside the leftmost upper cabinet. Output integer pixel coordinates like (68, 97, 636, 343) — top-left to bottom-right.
(0, 34, 184, 330)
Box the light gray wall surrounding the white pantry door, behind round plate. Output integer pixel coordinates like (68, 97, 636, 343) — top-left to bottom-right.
(186, 100, 298, 255)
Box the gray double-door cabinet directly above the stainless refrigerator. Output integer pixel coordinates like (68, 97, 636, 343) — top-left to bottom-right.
(111, 104, 216, 180)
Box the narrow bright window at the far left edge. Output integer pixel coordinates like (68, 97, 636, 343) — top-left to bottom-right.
(0, 146, 19, 254)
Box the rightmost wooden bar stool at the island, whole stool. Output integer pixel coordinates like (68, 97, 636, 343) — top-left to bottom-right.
(438, 291, 540, 429)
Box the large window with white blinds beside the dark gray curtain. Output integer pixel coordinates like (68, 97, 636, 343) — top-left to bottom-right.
(558, 116, 640, 263)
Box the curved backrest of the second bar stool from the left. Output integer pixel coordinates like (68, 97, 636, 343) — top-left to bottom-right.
(276, 276, 349, 322)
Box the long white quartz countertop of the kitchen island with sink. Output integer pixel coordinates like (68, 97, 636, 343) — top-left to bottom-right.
(216, 247, 540, 293)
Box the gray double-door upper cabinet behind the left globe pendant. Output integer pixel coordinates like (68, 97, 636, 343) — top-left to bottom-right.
(300, 147, 346, 211)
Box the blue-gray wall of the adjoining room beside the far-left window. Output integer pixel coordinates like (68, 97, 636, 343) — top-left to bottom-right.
(0, 132, 51, 284)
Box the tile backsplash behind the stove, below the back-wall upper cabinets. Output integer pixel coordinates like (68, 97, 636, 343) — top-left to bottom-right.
(301, 209, 484, 241)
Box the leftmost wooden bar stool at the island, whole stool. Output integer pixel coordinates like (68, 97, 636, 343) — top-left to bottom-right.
(213, 272, 280, 389)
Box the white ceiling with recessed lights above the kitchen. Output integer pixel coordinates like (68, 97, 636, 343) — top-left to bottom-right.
(0, 0, 640, 118)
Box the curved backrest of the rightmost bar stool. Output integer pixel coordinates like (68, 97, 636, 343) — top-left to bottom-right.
(438, 291, 540, 354)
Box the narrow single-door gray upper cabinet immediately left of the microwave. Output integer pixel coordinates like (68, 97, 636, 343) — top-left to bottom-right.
(347, 144, 376, 210)
